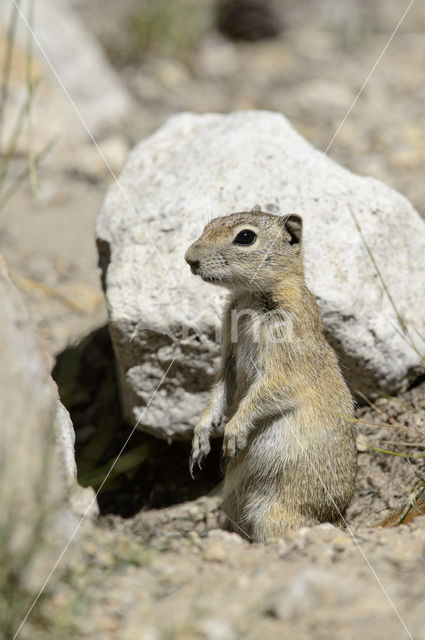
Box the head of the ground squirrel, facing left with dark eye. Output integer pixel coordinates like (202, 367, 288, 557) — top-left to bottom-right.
(185, 211, 303, 291)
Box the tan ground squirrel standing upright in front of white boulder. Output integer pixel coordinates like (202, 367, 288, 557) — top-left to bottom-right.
(185, 208, 356, 541)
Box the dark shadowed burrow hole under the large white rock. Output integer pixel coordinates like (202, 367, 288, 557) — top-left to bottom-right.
(53, 327, 222, 518)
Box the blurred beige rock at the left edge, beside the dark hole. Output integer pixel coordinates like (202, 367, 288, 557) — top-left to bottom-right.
(0, 258, 97, 560)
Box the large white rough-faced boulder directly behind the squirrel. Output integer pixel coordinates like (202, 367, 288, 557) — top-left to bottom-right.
(97, 111, 425, 437)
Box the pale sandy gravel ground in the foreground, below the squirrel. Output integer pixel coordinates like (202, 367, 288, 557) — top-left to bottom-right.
(49, 499, 425, 640)
